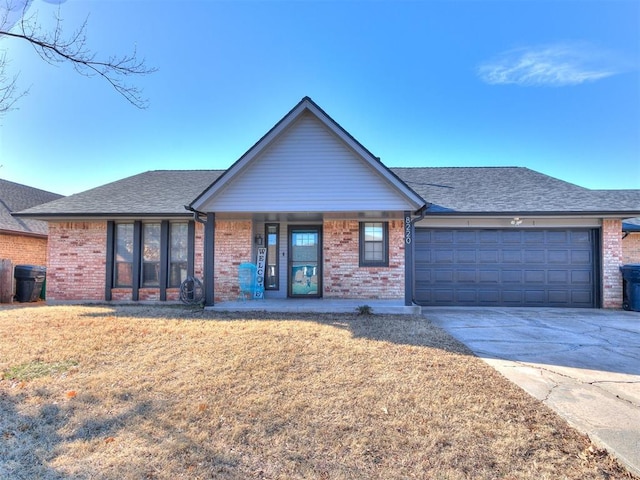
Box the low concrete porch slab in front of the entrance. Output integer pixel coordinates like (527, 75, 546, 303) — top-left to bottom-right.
(205, 298, 421, 315)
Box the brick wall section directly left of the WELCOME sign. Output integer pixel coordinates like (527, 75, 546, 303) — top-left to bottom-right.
(214, 220, 254, 302)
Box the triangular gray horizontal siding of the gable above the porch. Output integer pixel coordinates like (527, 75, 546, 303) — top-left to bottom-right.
(199, 112, 415, 212)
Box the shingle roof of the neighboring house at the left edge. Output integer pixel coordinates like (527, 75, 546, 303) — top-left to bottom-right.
(0, 179, 62, 235)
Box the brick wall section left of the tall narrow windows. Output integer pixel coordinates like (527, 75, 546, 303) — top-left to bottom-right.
(47, 222, 107, 300)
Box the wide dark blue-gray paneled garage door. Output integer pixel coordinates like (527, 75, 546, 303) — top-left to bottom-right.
(414, 228, 598, 308)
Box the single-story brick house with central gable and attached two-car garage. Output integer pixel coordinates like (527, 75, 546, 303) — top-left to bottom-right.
(15, 98, 640, 308)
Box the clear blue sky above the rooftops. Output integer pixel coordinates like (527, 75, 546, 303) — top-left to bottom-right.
(0, 0, 640, 195)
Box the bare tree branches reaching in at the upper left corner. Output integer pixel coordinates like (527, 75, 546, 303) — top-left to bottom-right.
(0, 0, 156, 114)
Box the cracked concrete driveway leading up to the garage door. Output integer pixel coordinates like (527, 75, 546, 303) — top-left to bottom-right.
(422, 307, 640, 475)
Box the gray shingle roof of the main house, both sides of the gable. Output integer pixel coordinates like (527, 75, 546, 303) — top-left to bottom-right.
(15, 167, 640, 218)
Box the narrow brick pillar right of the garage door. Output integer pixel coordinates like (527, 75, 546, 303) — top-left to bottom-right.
(602, 219, 623, 308)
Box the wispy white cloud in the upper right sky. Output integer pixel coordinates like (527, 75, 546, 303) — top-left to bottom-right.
(478, 43, 626, 87)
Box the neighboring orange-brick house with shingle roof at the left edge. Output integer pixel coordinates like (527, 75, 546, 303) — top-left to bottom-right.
(0, 179, 62, 266)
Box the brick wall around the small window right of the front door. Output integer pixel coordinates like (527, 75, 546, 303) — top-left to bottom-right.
(323, 220, 404, 299)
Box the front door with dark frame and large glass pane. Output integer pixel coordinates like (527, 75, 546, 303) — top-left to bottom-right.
(288, 225, 322, 298)
